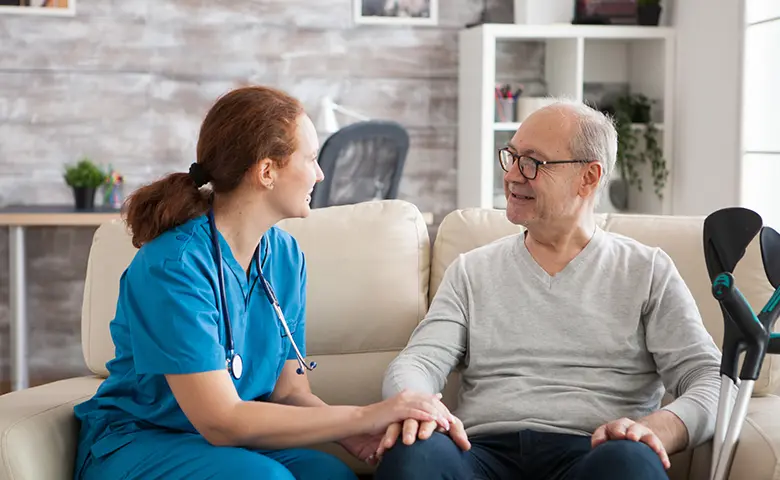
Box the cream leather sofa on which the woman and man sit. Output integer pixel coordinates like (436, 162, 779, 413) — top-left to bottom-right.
(0, 201, 780, 480)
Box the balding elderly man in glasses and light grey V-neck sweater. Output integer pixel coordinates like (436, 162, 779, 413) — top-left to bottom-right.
(376, 102, 720, 480)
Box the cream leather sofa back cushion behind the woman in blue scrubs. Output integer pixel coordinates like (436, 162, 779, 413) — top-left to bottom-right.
(82, 200, 430, 376)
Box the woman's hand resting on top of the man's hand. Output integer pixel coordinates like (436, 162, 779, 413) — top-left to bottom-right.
(362, 390, 453, 435)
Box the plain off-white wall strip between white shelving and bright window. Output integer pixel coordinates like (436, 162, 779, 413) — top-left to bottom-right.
(671, 0, 744, 215)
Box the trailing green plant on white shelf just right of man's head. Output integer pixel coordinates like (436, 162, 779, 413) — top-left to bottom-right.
(609, 94, 669, 210)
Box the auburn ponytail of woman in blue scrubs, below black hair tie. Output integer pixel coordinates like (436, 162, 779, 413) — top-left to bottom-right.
(122, 173, 210, 248)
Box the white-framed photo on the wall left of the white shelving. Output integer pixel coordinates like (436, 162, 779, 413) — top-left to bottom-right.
(352, 0, 439, 25)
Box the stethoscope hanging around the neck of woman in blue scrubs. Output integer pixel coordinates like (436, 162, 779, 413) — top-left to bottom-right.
(209, 209, 317, 380)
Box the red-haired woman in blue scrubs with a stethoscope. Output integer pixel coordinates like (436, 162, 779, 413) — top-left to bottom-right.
(74, 87, 451, 480)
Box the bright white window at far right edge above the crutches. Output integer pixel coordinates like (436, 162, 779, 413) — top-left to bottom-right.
(741, 0, 780, 230)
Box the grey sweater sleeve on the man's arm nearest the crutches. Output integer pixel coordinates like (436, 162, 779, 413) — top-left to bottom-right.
(644, 249, 721, 447)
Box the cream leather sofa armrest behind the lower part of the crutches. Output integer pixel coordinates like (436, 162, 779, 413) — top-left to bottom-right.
(689, 395, 780, 480)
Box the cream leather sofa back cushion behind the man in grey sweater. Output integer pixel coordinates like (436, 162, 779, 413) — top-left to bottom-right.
(431, 209, 780, 395)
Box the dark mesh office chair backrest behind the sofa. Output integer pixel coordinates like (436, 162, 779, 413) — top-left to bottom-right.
(311, 120, 409, 208)
